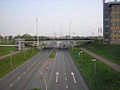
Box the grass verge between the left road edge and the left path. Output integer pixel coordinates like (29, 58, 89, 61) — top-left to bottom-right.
(0, 48, 40, 78)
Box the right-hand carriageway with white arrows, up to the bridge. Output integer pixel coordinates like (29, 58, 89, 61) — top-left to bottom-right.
(45, 50, 89, 90)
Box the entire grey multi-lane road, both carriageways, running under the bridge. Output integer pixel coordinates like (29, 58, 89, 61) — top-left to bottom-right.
(0, 42, 89, 90)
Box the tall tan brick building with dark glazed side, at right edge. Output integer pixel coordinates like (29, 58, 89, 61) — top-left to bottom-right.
(103, 0, 120, 44)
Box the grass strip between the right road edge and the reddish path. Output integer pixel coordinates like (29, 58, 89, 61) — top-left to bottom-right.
(70, 49, 120, 90)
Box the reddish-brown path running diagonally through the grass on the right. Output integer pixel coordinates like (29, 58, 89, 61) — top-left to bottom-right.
(80, 48, 120, 72)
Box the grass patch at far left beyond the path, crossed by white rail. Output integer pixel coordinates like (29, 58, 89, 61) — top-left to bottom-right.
(0, 41, 15, 56)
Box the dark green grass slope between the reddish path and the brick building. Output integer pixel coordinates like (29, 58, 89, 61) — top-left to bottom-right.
(84, 41, 120, 65)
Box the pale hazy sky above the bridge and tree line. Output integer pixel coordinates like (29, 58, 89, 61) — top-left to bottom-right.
(0, 0, 117, 36)
